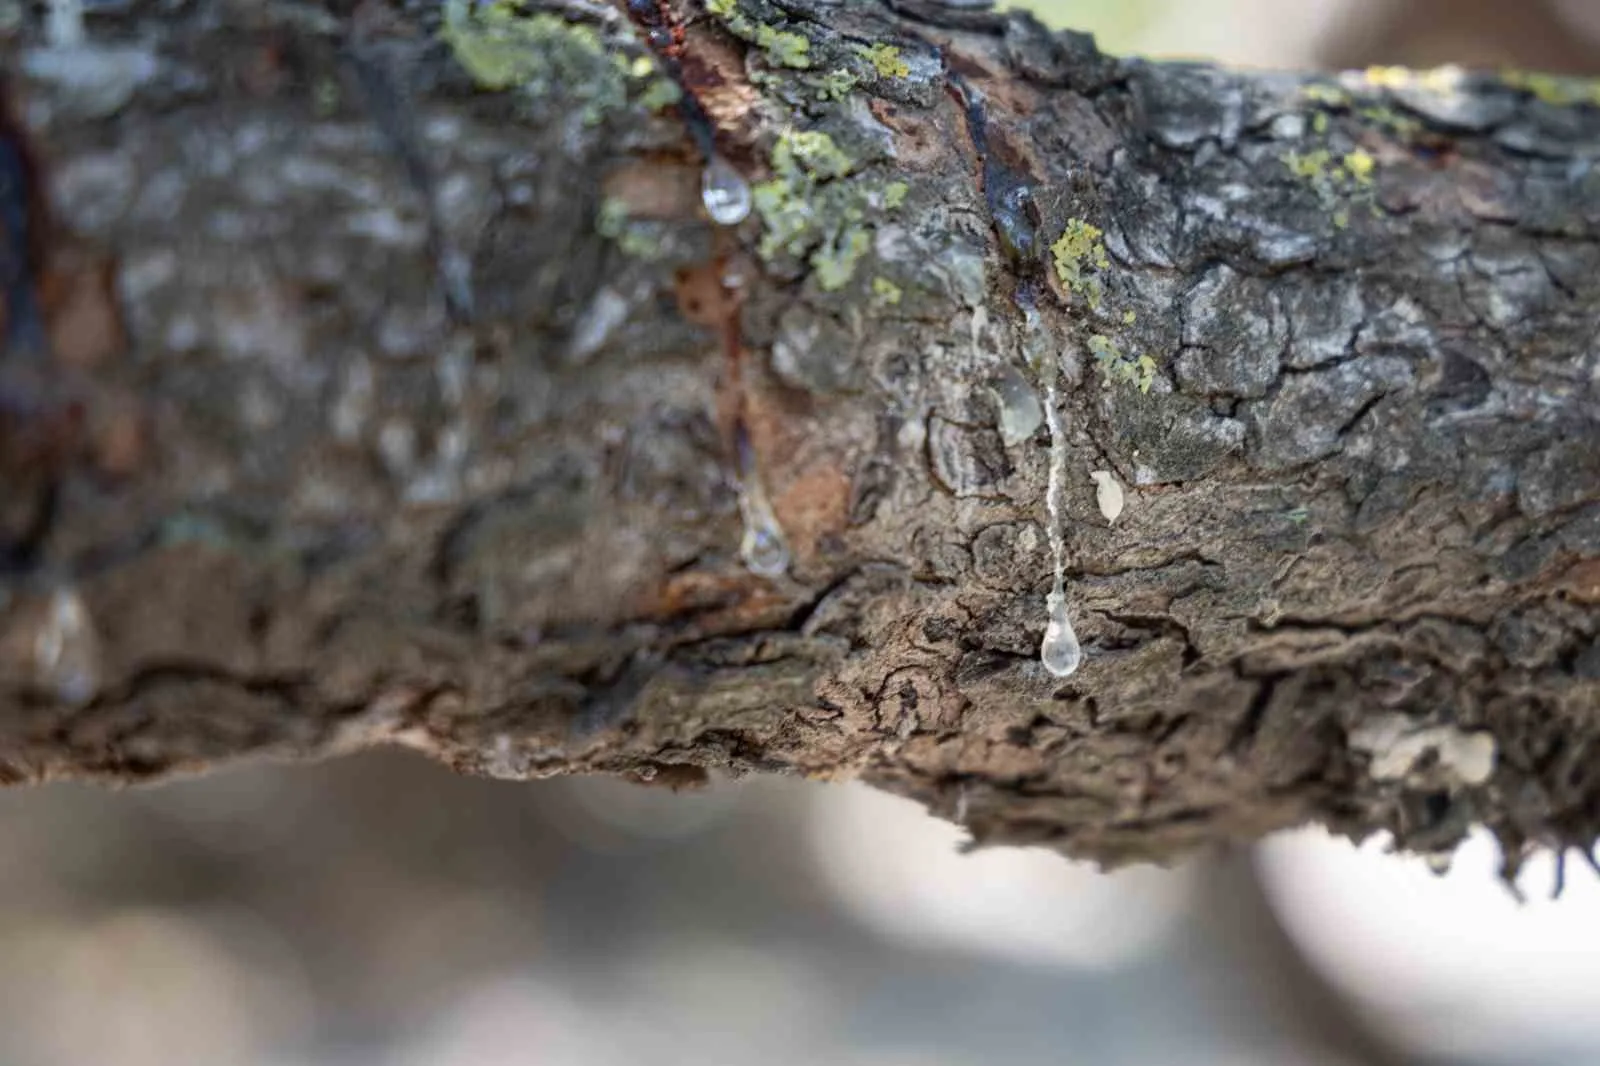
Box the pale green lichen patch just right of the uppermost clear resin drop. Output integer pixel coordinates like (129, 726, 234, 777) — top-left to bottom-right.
(750, 130, 907, 291)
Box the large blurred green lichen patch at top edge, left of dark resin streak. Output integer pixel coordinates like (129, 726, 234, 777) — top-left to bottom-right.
(440, 0, 678, 125)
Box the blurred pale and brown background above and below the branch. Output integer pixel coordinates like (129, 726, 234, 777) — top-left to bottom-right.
(9, 0, 1600, 1066)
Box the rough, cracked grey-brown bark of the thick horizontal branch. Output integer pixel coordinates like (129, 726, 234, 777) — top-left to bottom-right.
(0, 0, 1600, 874)
